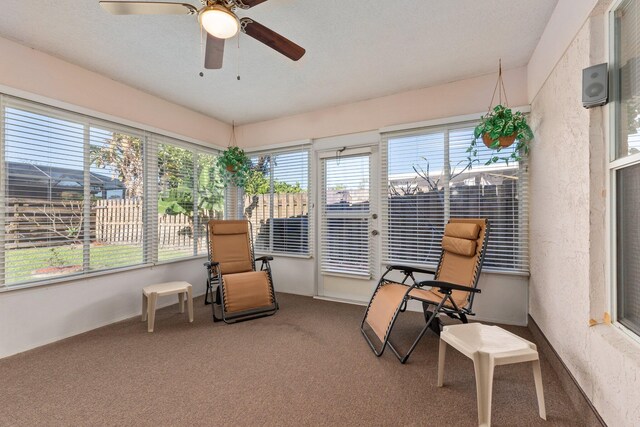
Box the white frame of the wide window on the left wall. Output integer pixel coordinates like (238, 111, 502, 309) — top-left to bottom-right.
(0, 92, 226, 293)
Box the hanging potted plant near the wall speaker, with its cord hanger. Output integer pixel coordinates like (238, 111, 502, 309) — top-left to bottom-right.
(467, 59, 533, 165)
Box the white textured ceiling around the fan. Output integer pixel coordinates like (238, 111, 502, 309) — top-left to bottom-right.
(0, 0, 557, 124)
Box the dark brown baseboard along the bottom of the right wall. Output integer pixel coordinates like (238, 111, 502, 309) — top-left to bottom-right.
(527, 315, 606, 427)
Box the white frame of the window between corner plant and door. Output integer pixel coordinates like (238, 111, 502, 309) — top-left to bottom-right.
(242, 145, 315, 259)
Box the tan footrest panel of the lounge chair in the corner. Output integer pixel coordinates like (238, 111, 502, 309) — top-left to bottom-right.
(222, 271, 273, 313)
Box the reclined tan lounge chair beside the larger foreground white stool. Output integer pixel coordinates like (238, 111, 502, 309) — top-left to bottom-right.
(360, 218, 489, 363)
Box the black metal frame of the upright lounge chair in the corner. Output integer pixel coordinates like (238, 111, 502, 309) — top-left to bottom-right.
(204, 221, 279, 324)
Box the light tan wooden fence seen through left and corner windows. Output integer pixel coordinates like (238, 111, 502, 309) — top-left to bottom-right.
(5, 193, 309, 249)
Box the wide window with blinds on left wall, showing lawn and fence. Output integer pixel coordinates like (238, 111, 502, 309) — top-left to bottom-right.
(0, 95, 223, 288)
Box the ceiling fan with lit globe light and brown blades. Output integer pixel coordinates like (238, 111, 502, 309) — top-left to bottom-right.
(100, 0, 305, 69)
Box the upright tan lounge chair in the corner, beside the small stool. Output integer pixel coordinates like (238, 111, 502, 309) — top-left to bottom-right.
(205, 220, 278, 323)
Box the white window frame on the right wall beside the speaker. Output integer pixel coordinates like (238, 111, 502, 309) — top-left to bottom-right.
(605, 0, 640, 343)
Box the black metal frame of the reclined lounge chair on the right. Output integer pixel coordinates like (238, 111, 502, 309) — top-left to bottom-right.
(360, 220, 490, 364)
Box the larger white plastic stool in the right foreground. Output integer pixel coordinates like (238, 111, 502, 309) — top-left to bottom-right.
(438, 323, 547, 426)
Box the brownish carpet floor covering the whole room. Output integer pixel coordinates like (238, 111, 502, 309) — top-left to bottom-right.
(0, 294, 580, 426)
